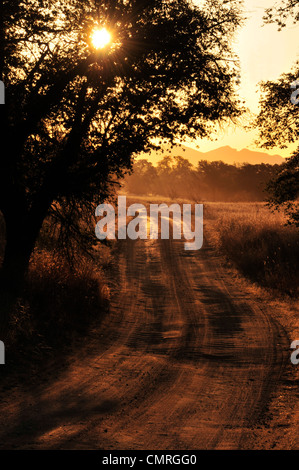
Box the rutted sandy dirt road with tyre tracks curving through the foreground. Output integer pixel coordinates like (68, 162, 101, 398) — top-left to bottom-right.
(0, 217, 289, 450)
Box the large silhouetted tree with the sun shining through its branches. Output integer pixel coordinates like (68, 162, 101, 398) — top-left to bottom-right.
(0, 0, 241, 302)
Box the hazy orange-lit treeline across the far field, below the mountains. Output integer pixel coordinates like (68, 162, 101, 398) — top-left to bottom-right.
(125, 156, 280, 202)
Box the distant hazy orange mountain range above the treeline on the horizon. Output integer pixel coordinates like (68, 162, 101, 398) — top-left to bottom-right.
(139, 145, 285, 166)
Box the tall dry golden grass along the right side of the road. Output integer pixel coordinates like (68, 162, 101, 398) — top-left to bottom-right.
(206, 203, 299, 296)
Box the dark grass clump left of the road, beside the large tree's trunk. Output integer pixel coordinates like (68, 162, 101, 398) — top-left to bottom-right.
(6, 251, 108, 364)
